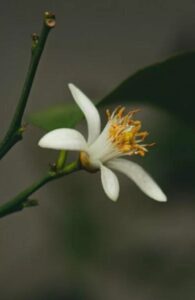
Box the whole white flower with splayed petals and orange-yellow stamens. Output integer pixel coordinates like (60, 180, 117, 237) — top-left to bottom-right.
(39, 84, 167, 202)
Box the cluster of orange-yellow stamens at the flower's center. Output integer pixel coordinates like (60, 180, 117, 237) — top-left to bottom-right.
(106, 106, 154, 156)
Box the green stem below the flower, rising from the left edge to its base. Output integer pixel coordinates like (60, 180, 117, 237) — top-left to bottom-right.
(0, 162, 80, 218)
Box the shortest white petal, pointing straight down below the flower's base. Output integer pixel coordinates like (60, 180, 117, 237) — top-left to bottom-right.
(100, 165, 119, 201)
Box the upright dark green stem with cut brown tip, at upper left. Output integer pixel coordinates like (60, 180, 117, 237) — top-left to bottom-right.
(0, 13, 55, 159)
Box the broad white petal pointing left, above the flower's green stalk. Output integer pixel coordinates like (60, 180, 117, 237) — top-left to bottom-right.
(38, 128, 87, 151)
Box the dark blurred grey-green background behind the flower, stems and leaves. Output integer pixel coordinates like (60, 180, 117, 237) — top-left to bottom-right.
(0, 0, 195, 300)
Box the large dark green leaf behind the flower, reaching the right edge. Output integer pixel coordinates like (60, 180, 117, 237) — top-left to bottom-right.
(100, 52, 195, 126)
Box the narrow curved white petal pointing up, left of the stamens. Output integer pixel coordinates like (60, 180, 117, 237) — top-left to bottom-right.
(68, 83, 101, 144)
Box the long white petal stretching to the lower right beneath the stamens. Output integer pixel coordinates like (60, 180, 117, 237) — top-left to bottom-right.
(107, 158, 167, 202)
